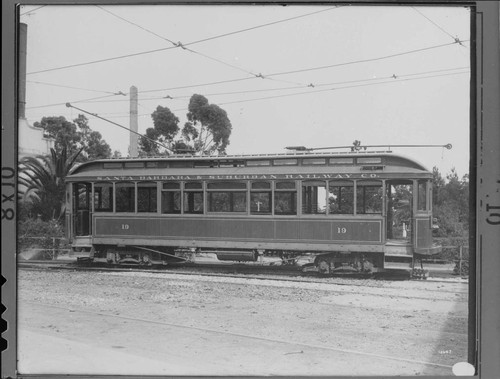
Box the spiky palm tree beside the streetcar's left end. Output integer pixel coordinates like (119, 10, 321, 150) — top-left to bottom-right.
(18, 148, 82, 221)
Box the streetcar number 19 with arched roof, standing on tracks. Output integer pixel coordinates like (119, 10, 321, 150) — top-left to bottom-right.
(66, 151, 441, 275)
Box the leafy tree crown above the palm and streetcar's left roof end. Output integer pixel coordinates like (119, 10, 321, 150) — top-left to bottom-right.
(34, 114, 111, 162)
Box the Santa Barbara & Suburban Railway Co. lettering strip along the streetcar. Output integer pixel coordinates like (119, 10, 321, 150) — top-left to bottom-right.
(93, 173, 380, 181)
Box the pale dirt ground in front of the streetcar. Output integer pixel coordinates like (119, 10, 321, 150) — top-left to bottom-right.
(14, 270, 468, 376)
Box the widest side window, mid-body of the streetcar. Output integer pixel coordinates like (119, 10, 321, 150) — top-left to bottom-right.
(208, 182, 247, 212)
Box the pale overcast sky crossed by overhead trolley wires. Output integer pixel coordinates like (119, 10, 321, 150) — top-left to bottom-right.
(20, 5, 470, 176)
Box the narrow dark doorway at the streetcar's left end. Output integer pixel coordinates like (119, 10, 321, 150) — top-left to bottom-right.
(73, 183, 92, 236)
